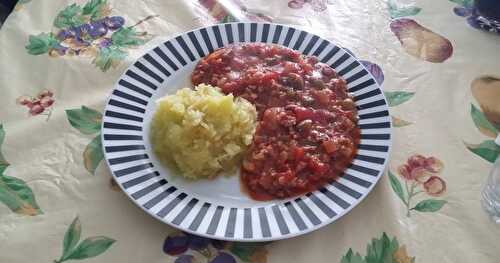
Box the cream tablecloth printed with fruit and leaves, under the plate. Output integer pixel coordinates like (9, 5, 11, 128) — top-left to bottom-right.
(0, 0, 500, 263)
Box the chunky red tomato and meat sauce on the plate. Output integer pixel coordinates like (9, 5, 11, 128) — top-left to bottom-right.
(192, 43, 360, 200)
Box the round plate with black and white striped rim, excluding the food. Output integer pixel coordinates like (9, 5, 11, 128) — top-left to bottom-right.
(102, 23, 391, 241)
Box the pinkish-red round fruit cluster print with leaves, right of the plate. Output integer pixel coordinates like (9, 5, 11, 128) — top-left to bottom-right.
(389, 154, 446, 217)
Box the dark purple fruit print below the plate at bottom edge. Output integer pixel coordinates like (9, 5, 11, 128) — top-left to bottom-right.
(163, 231, 267, 263)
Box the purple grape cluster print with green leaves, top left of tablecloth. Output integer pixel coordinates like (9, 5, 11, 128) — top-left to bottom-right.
(25, 0, 156, 71)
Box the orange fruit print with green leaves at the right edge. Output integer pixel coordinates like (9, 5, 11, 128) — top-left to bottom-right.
(464, 75, 500, 163)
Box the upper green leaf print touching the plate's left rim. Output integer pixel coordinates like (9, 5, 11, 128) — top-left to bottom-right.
(66, 106, 102, 135)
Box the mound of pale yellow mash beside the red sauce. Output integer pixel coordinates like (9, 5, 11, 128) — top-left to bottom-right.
(151, 84, 257, 179)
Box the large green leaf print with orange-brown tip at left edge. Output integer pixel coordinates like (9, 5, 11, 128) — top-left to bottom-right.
(0, 174, 42, 216)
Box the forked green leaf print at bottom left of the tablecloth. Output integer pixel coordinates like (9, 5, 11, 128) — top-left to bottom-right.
(54, 217, 116, 263)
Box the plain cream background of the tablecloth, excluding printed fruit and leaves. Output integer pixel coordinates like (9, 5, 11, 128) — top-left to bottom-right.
(0, 0, 500, 263)
